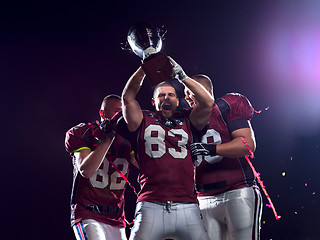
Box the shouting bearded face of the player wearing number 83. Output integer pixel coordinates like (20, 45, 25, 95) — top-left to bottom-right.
(152, 86, 179, 118)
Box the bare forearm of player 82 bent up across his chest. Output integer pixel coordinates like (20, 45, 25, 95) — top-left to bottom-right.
(79, 136, 114, 178)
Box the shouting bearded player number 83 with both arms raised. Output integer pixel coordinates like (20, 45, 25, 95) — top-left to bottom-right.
(120, 59, 213, 240)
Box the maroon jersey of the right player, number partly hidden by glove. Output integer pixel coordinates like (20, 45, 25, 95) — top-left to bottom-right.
(196, 93, 255, 196)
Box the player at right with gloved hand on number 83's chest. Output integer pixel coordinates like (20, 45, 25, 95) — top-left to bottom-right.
(185, 75, 262, 240)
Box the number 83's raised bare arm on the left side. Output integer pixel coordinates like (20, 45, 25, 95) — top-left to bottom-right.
(121, 67, 145, 132)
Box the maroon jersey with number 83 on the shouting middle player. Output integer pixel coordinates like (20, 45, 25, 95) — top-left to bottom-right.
(125, 111, 197, 203)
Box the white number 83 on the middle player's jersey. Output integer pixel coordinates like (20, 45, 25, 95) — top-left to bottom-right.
(144, 124, 188, 158)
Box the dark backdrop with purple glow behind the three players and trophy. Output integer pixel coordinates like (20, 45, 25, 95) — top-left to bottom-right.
(0, 0, 320, 240)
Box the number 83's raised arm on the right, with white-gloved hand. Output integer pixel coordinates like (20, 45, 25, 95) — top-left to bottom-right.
(169, 57, 214, 130)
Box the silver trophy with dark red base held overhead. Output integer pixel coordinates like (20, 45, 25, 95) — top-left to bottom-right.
(123, 22, 172, 85)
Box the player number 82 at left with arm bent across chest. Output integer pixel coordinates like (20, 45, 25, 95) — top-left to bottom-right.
(65, 94, 137, 240)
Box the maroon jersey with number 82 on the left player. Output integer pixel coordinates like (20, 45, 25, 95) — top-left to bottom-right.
(65, 123, 131, 228)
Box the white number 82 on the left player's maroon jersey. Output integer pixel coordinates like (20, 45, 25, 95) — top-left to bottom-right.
(89, 158, 129, 190)
